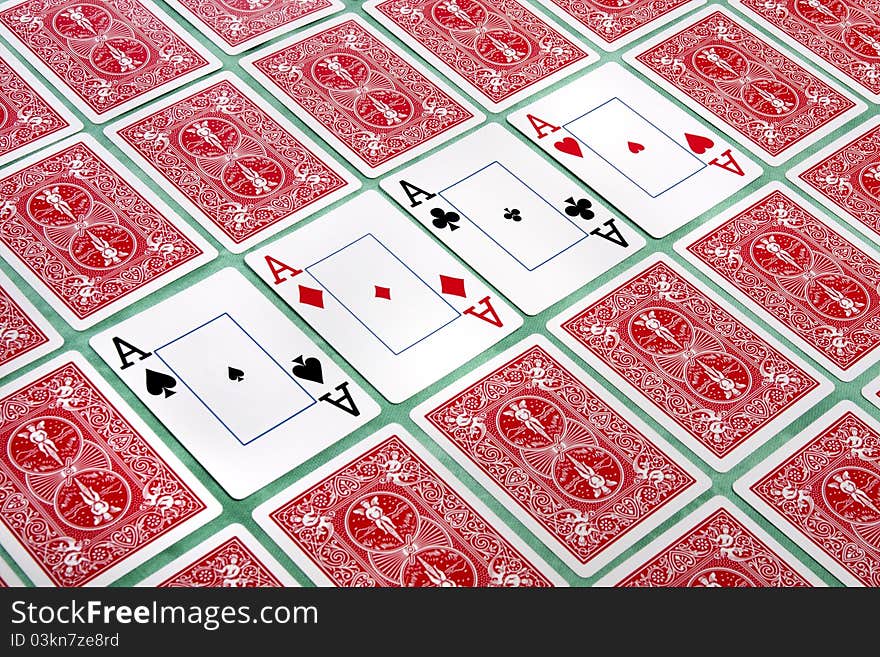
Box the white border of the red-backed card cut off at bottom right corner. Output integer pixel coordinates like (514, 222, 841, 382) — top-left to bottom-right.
(733, 400, 880, 586)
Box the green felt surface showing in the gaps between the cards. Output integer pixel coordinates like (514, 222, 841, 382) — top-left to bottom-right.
(0, 0, 880, 586)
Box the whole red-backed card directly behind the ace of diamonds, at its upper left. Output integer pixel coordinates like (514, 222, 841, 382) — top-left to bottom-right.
(104, 73, 360, 253)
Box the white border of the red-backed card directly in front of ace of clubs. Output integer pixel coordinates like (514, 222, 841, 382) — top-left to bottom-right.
(547, 253, 834, 472)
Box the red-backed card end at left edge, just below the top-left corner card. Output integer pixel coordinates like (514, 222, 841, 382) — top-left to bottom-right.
(0, 44, 82, 164)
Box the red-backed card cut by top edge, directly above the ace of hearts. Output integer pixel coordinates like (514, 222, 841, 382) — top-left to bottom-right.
(541, 0, 706, 51)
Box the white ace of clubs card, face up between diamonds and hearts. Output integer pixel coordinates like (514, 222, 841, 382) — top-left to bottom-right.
(381, 124, 645, 315)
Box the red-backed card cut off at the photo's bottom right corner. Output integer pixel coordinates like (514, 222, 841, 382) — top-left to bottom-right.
(733, 401, 880, 586)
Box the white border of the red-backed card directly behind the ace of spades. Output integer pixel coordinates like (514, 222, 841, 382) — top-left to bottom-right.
(0, 133, 217, 331)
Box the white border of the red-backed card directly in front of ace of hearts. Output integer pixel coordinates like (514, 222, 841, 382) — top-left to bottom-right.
(672, 181, 880, 382)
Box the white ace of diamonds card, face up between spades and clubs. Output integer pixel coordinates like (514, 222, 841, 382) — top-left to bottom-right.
(245, 192, 522, 403)
